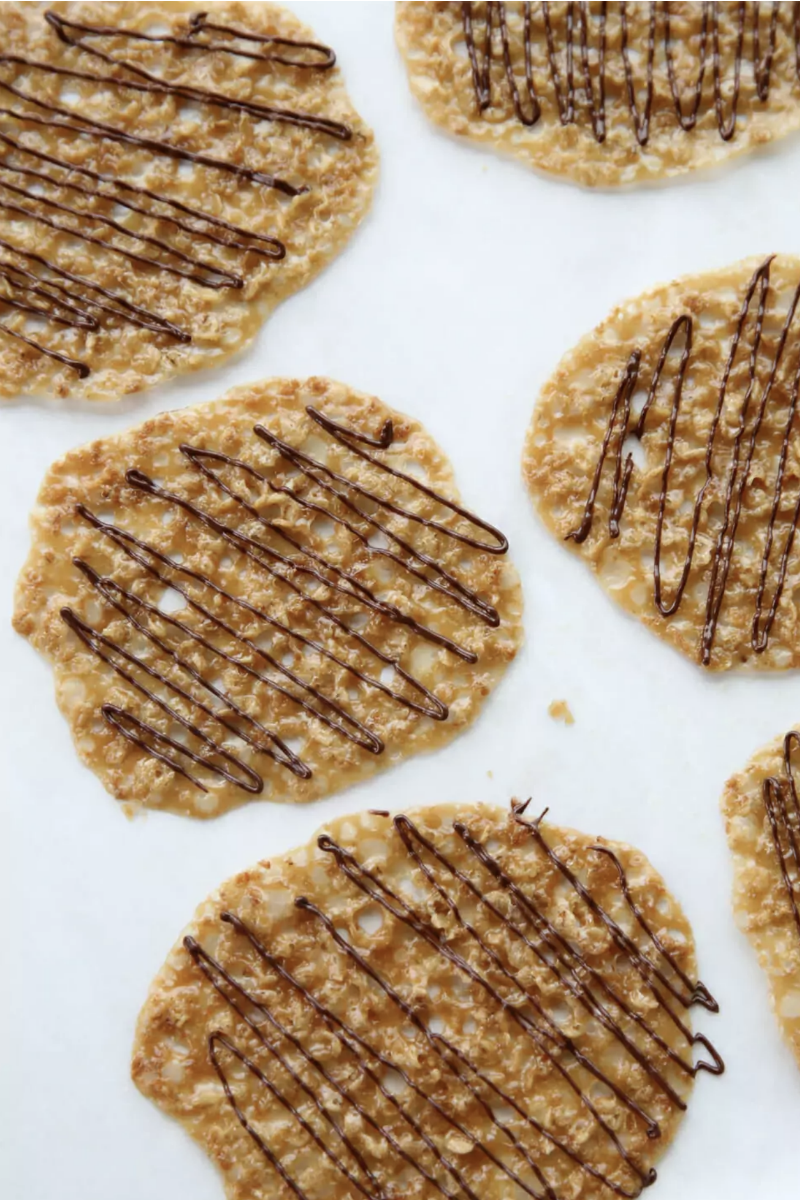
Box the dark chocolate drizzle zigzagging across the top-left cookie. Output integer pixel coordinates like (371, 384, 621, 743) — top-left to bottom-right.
(0, 12, 353, 369)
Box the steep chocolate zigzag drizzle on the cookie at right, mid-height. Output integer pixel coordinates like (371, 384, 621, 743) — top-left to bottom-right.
(567, 258, 800, 666)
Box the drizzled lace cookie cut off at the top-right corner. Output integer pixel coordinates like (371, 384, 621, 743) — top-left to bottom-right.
(397, 0, 800, 187)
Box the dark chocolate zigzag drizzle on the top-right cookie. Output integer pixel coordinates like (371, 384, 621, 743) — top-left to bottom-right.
(461, 0, 800, 146)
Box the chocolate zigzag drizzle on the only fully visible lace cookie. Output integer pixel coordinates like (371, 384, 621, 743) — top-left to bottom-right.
(61, 408, 507, 794)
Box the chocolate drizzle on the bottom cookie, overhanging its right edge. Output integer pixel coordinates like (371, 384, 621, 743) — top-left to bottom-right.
(184, 805, 724, 1200)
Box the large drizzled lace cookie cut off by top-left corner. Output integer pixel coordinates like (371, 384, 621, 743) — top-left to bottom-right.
(0, 0, 378, 400)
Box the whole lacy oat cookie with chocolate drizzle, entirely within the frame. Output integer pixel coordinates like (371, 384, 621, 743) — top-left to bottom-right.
(14, 379, 522, 817)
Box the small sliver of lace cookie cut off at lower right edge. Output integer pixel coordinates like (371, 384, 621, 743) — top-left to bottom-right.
(722, 730, 800, 1066)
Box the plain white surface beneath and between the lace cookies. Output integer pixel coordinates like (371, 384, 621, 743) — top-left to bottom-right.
(0, 0, 800, 1200)
